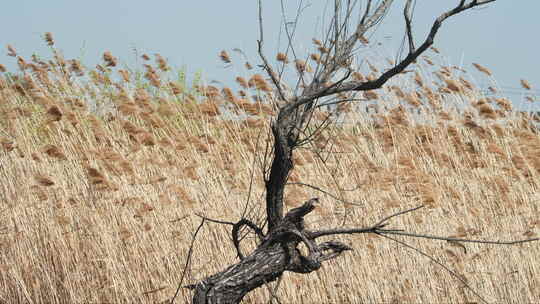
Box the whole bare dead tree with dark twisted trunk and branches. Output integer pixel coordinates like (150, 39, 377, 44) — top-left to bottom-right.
(179, 0, 537, 304)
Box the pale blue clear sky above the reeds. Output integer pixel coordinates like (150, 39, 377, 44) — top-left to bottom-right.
(0, 0, 540, 110)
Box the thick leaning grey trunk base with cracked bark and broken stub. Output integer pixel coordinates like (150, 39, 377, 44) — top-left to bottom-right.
(190, 199, 351, 304)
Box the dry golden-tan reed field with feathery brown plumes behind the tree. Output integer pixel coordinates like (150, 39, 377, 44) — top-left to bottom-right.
(0, 34, 540, 303)
